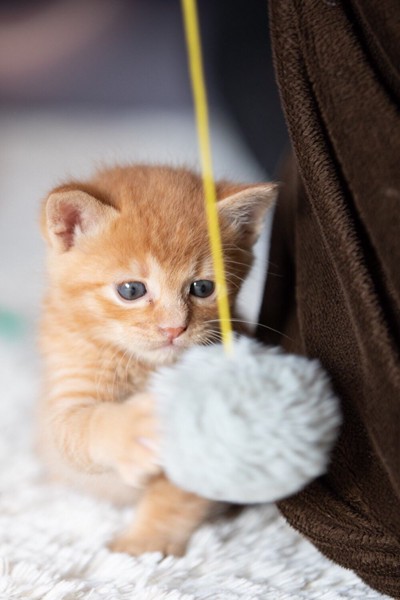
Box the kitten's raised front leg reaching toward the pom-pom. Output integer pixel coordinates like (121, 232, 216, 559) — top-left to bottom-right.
(39, 392, 160, 487)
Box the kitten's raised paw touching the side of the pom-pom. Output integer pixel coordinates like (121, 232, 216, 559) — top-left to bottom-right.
(90, 394, 161, 487)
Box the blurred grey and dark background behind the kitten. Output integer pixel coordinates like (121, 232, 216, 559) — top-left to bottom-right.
(0, 0, 287, 326)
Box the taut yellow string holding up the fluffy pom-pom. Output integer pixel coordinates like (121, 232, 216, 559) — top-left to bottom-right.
(181, 0, 233, 352)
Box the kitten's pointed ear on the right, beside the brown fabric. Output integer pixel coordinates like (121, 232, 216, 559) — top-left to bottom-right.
(218, 183, 279, 246)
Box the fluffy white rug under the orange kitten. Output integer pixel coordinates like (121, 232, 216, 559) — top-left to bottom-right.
(0, 336, 390, 600)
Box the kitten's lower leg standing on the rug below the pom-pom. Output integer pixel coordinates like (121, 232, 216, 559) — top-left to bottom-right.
(110, 475, 216, 556)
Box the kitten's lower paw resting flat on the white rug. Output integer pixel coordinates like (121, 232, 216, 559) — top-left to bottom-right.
(108, 534, 187, 556)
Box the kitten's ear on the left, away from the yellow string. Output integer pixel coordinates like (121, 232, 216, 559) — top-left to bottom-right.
(42, 187, 118, 252)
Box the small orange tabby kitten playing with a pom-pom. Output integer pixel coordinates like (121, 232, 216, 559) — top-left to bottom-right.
(39, 165, 276, 555)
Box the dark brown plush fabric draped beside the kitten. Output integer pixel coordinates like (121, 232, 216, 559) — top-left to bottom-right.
(259, 0, 400, 598)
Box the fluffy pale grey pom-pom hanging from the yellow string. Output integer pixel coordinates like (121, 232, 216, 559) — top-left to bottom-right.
(151, 337, 340, 503)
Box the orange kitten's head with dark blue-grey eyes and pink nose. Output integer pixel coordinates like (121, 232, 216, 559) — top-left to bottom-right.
(42, 166, 276, 365)
